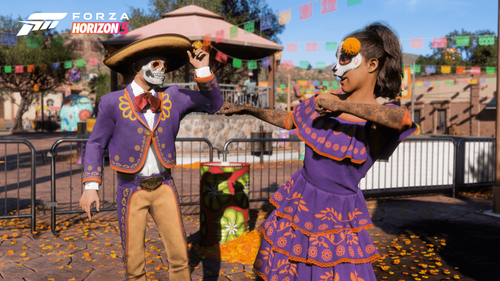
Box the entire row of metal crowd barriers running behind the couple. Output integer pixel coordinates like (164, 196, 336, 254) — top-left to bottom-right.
(0, 137, 495, 234)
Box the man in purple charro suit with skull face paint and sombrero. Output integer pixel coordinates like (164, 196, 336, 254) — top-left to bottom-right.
(80, 34, 222, 281)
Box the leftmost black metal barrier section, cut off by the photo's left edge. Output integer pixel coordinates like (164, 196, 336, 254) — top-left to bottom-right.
(0, 139, 38, 234)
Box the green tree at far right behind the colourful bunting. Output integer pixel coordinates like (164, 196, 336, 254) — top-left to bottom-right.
(415, 29, 498, 74)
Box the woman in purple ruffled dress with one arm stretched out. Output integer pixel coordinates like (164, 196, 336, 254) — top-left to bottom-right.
(220, 23, 416, 281)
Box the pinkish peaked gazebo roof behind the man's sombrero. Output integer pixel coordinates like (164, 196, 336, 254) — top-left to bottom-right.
(103, 5, 283, 60)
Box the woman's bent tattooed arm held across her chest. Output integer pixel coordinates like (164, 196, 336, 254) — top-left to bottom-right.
(322, 99, 411, 131)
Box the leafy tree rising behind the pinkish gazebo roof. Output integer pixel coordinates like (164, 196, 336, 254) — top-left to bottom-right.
(128, 0, 285, 83)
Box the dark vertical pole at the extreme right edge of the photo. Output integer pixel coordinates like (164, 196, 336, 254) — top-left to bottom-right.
(493, 0, 500, 214)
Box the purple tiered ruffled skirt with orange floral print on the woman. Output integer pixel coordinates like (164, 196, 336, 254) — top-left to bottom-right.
(254, 170, 380, 281)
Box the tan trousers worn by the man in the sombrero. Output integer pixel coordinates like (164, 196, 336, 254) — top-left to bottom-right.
(122, 184, 191, 281)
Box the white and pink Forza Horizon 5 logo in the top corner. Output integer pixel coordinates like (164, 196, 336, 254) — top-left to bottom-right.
(17, 13, 130, 36)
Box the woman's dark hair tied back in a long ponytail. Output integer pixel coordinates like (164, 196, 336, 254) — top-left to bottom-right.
(344, 22, 403, 99)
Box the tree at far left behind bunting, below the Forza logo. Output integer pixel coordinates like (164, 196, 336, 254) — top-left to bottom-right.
(0, 16, 75, 132)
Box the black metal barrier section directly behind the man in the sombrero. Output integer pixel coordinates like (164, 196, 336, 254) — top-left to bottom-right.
(45, 138, 213, 235)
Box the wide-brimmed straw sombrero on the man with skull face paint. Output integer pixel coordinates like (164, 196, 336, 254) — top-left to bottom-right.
(103, 33, 192, 74)
